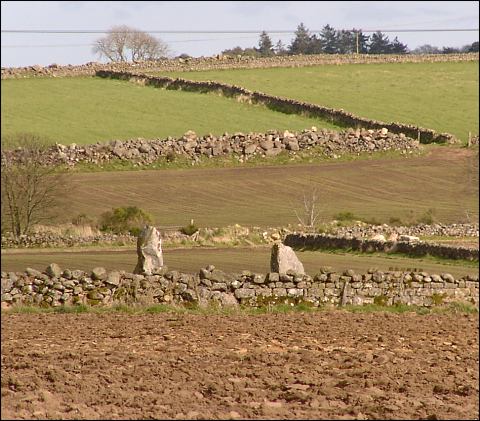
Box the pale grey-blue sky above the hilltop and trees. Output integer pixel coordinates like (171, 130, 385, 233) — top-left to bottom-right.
(1, 1, 479, 67)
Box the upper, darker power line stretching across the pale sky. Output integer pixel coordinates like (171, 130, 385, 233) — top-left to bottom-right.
(1, 28, 479, 34)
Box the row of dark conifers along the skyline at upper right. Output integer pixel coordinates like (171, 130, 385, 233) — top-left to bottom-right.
(222, 23, 478, 57)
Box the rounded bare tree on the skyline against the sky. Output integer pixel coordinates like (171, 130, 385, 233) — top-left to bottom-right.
(93, 25, 168, 61)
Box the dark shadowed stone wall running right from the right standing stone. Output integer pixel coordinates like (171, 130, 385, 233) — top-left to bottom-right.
(284, 234, 479, 261)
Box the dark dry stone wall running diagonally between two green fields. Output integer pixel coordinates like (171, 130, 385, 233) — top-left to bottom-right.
(96, 70, 459, 143)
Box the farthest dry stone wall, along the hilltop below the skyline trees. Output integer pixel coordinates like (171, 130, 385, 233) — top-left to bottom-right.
(1, 53, 479, 79)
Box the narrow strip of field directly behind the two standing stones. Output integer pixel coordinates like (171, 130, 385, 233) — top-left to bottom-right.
(1, 247, 478, 276)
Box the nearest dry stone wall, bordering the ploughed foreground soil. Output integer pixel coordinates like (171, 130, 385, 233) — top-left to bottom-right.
(1, 264, 479, 308)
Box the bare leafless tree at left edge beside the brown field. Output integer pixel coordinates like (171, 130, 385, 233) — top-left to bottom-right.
(1, 134, 67, 237)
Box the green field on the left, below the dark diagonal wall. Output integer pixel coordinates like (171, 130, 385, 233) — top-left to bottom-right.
(1, 77, 336, 145)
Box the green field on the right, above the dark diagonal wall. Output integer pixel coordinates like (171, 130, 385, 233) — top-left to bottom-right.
(156, 62, 479, 140)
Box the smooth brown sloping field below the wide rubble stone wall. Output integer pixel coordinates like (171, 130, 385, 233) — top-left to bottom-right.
(56, 146, 478, 227)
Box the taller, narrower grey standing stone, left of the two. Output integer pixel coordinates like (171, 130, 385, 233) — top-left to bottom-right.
(133, 225, 163, 275)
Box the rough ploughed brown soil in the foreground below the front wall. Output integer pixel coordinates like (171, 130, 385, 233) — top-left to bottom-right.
(1, 311, 479, 419)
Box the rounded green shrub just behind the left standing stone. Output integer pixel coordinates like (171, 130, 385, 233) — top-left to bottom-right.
(99, 206, 152, 235)
